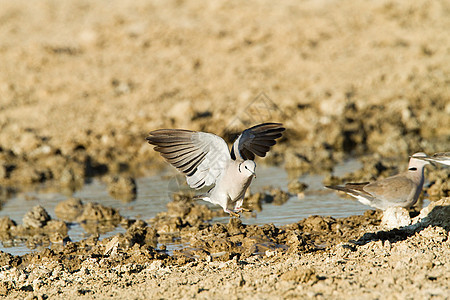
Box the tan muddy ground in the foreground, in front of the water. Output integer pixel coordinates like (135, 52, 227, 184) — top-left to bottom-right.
(0, 197, 450, 299)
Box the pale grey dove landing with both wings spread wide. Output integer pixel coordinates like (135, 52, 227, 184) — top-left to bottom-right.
(147, 123, 285, 214)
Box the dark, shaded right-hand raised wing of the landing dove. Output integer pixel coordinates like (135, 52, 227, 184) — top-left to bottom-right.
(231, 123, 285, 160)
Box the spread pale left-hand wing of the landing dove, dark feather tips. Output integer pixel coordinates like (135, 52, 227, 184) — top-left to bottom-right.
(147, 129, 231, 189)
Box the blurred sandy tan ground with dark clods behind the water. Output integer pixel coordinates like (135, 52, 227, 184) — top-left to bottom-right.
(0, 0, 450, 185)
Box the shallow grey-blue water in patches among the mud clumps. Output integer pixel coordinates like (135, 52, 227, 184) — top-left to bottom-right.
(0, 160, 369, 255)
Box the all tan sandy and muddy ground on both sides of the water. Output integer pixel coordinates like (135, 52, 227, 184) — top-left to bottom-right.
(0, 0, 450, 299)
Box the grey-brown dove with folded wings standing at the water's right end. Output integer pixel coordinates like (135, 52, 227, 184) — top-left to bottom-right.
(326, 152, 429, 210)
